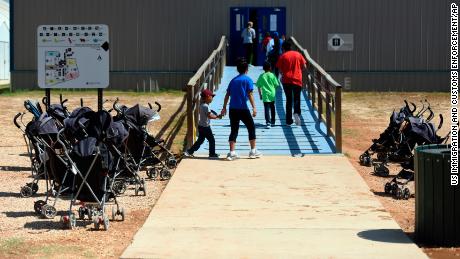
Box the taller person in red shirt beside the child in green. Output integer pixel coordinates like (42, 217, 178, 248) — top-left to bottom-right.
(276, 41, 307, 126)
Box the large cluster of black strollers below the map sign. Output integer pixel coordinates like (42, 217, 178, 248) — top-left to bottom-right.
(14, 96, 177, 230)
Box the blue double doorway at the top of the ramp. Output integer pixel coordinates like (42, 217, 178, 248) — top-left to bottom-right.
(227, 7, 286, 66)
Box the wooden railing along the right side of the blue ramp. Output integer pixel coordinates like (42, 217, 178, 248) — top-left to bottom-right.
(290, 37, 342, 153)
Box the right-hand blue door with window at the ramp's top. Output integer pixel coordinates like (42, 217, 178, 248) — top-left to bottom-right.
(255, 7, 286, 66)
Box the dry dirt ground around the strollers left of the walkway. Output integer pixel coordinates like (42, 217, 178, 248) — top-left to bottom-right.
(0, 91, 186, 258)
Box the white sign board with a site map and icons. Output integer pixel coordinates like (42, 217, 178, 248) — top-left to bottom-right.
(37, 24, 109, 88)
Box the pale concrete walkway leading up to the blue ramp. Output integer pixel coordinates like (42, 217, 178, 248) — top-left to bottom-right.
(122, 154, 426, 258)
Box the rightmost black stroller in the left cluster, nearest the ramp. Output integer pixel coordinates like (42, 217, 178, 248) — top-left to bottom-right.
(113, 99, 177, 183)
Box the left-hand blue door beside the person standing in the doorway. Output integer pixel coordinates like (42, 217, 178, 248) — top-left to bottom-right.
(227, 7, 249, 65)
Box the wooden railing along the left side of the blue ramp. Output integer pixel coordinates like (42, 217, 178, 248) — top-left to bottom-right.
(187, 36, 227, 148)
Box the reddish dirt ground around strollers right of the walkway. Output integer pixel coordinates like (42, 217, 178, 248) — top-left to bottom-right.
(342, 93, 460, 258)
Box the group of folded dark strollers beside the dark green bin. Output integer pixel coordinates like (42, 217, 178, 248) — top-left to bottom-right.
(359, 100, 450, 200)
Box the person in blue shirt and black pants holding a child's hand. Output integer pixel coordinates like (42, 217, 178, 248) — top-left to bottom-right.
(221, 58, 262, 161)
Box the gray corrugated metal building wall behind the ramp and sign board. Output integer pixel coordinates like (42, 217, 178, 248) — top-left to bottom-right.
(11, 0, 451, 91)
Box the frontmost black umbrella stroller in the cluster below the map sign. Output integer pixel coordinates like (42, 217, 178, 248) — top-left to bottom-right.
(54, 107, 124, 230)
